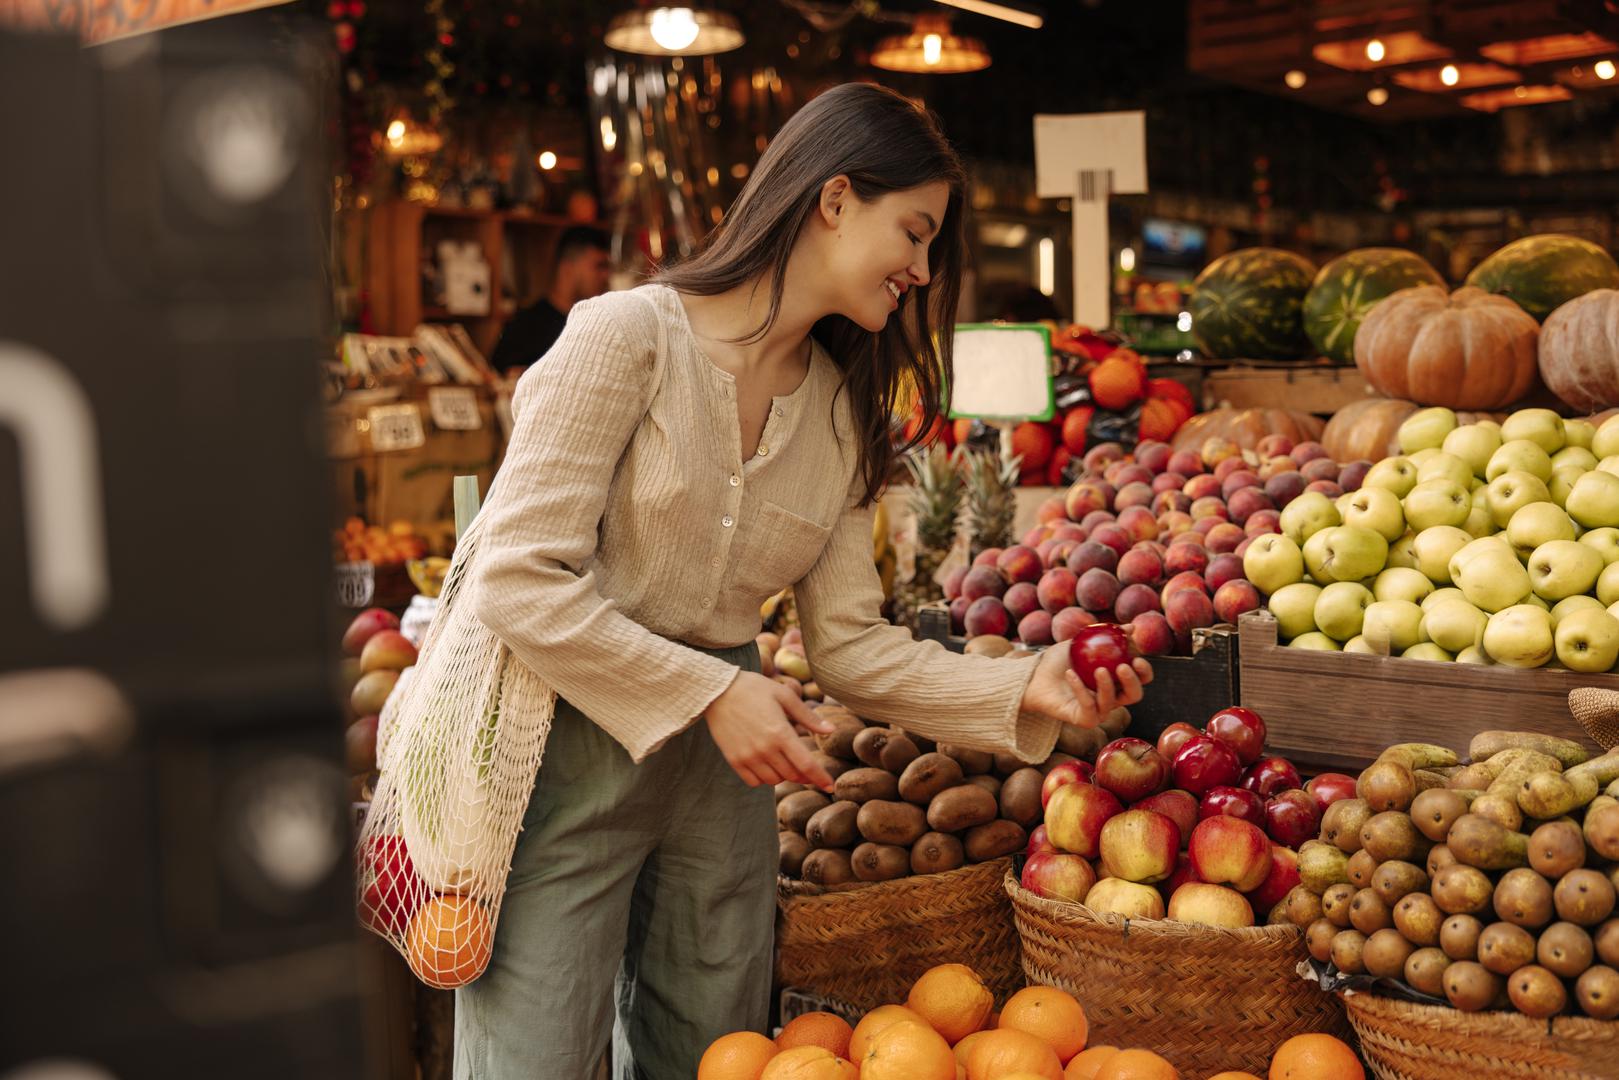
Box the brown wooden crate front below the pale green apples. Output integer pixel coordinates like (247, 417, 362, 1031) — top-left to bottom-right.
(1240, 610, 1619, 771)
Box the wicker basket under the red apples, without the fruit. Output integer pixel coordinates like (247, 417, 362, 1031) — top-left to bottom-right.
(1005, 873, 1349, 1077)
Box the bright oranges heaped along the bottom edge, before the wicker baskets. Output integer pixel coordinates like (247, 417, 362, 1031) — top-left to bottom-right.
(696, 963, 1366, 1080)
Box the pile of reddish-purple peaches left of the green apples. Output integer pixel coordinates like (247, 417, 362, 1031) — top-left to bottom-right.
(944, 436, 1365, 656)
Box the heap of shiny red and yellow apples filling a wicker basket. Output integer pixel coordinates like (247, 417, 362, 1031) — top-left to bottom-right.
(1022, 706, 1355, 926)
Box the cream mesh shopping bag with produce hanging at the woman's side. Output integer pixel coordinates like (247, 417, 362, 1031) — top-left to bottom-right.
(356, 515, 557, 989)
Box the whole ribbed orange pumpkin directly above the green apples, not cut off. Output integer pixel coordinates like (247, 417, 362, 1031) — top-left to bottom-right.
(1355, 285, 1540, 408)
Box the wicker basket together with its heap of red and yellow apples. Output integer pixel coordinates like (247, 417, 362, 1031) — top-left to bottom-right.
(1004, 706, 1355, 1075)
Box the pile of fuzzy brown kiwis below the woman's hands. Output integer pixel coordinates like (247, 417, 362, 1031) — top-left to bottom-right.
(776, 703, 1130, 886)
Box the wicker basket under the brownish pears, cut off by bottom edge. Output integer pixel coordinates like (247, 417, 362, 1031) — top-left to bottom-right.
(1344, 993, 1619, 1080)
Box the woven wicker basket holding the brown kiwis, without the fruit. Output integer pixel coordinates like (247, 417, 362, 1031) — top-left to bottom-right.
(776, 858, 1023, 1012)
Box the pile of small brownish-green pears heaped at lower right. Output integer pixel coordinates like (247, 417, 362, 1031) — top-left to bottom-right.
(1285, 732, 1619, 1020)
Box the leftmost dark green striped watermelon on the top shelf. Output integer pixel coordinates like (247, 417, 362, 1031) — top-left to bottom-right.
(1192, 248, 1315, 359)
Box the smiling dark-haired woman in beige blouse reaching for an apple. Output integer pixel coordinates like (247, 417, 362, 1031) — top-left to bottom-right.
(457, 84, 1151, 1080)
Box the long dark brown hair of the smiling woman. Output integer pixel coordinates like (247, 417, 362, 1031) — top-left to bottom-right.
(654, 83, 967, 505)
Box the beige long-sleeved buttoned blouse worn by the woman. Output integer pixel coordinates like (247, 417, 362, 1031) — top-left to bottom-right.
(470, 285, 1057, 761)
